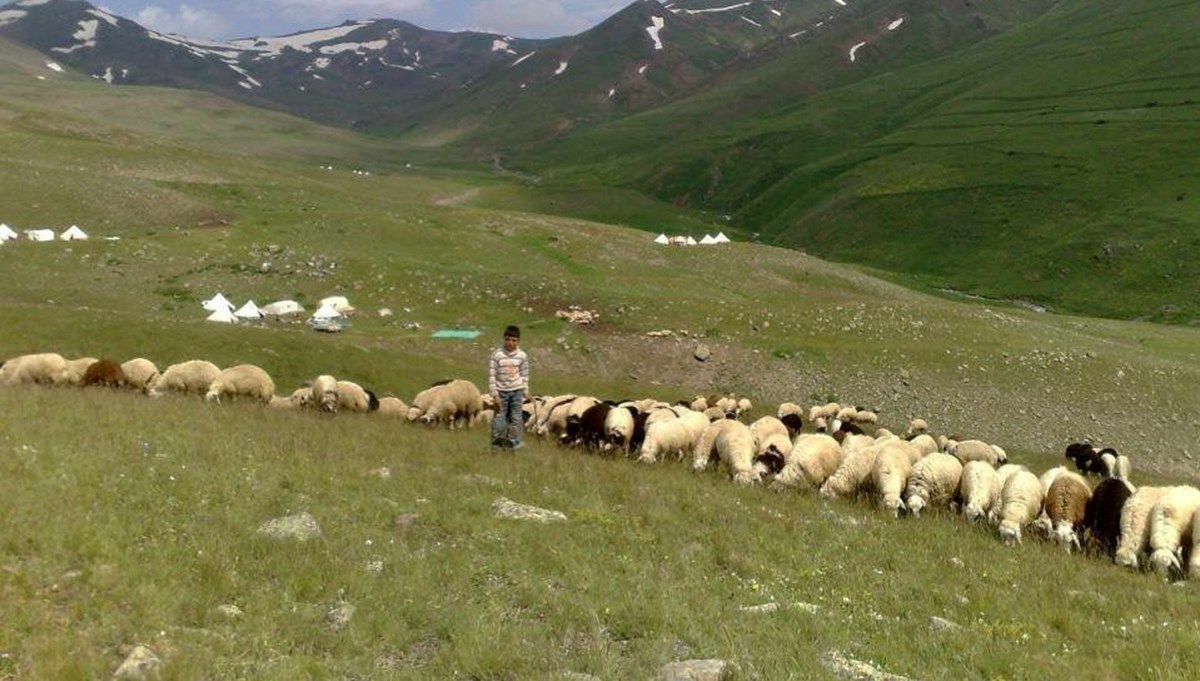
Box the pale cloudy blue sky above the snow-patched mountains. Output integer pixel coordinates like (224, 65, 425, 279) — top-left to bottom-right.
(93, 0, 634, 40)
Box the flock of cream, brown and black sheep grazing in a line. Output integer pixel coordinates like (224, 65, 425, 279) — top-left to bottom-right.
(0, 352, 1200, 578)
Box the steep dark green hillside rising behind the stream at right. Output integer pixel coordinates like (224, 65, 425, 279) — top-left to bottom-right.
(526, 0, 1200, 324)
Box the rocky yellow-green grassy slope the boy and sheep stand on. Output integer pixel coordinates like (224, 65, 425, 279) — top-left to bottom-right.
(7, 23, 1200, 680)
